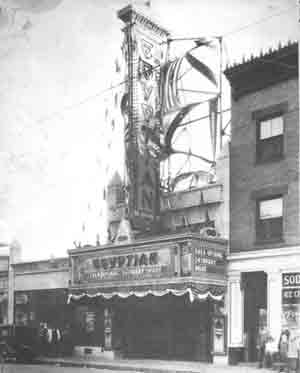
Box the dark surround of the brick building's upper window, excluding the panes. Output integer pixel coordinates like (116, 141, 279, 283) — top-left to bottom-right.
(256, 110, 285, 164)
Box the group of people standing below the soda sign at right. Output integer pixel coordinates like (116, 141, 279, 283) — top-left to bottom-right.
(257, 327, 300, 370)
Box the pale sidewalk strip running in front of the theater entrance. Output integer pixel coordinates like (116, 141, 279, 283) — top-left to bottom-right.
(37, 356, 270, 373)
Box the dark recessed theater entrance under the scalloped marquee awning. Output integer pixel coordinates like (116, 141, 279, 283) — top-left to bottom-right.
(113, 295, 213, 362)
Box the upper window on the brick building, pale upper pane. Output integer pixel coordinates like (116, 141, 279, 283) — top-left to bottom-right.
(257, 115, 283, 162)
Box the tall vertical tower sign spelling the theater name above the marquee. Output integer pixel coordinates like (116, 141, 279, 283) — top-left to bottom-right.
(118, 6, 168, 231)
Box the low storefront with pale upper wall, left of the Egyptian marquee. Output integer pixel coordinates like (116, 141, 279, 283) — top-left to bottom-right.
(11, 258, 70, 330)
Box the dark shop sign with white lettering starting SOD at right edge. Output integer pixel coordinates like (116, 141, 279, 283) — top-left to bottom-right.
(281, 272, 300, 329)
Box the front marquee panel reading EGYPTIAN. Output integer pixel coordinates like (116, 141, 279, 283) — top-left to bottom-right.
(74, 248, 174, 283)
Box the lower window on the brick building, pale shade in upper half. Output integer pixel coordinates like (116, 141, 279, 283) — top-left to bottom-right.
(256, 197, 283, 241)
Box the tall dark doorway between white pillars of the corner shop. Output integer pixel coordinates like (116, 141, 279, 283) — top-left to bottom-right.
(242, 271, 267, 361)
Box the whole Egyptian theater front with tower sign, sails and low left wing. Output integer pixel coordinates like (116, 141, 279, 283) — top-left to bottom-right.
(0, 6, 229, 362)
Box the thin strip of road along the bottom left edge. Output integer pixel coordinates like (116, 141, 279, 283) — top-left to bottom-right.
(0, 364, 133, 373)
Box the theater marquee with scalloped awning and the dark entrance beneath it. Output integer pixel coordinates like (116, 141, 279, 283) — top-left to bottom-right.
(69, 234, 226, 361)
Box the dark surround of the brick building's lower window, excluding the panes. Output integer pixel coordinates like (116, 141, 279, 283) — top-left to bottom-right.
(255, 194, 284, 243)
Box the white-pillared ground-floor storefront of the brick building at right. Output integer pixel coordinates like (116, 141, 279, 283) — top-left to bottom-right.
(228, 247, 300, 361)
